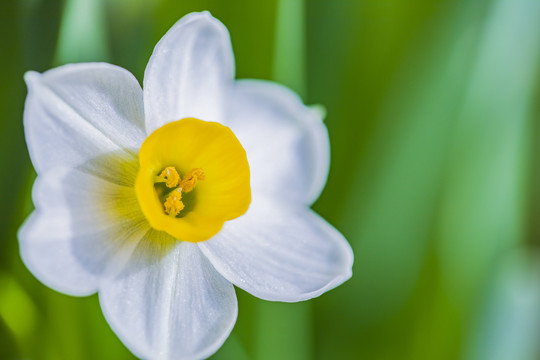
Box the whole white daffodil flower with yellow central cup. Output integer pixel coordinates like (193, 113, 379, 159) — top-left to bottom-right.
(19, 13, 352, 359)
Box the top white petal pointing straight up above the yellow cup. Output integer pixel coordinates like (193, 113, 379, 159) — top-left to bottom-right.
(143, 12, 234, 133)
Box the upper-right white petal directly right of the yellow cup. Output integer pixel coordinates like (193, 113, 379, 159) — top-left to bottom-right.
(225, 80, 330, 205)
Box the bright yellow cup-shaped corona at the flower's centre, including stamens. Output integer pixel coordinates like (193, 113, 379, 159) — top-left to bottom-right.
(135, 118, 251, 242)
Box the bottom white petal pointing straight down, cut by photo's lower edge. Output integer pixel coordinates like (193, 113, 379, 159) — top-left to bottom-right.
(99, 238, 238, 359)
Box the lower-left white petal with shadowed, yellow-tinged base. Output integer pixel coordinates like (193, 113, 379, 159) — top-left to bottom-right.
(19, 167, 149, 296)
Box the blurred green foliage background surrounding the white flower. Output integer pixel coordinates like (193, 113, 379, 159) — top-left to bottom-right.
(0, 0, 540, 360)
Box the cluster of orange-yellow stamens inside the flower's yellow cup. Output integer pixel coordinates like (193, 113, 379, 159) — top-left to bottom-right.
(159, 166, 205, 217)
